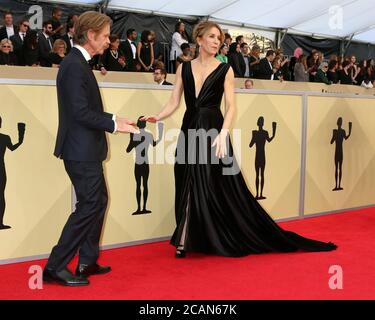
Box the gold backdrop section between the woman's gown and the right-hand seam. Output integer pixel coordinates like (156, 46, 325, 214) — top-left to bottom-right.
(233, 93, 302, 219)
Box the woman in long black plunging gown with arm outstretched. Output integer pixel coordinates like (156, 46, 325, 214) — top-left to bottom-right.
(142, 21, 337, 257)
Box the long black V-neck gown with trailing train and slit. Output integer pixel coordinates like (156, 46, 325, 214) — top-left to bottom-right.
(171, 62, 337, 257)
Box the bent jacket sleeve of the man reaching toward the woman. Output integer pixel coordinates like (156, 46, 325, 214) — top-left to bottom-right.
(65, 63, 115, 133)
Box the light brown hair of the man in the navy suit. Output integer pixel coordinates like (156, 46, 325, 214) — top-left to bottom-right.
(74, 11, 112, 45)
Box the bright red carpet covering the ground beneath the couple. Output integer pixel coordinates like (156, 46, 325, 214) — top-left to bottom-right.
(0, 208, 375, 300)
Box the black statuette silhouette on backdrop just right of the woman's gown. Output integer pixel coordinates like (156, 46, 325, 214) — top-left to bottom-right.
(249, 117, 277, 200)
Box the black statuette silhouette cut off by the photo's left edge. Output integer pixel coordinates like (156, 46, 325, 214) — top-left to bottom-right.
(0, 117, 26, 230)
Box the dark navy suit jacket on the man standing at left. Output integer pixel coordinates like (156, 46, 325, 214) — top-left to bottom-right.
(54, 48, 115, 161)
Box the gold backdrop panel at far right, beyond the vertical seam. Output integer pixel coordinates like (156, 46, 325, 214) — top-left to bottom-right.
(305, 97, 375, 214)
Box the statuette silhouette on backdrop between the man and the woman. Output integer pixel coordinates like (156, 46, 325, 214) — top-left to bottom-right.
(126, 117, 164, 215)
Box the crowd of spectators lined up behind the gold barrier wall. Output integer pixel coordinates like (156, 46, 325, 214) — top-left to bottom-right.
(0, 8, 375, 88)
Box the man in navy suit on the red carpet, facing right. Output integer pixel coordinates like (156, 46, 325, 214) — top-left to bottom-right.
(43, 11, 139, 286)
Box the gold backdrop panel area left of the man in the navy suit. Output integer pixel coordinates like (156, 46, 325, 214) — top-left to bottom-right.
(0, 85, 71, 260)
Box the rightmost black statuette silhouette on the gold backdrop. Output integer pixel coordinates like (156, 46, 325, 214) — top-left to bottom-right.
(331, 117, 352, 191)
